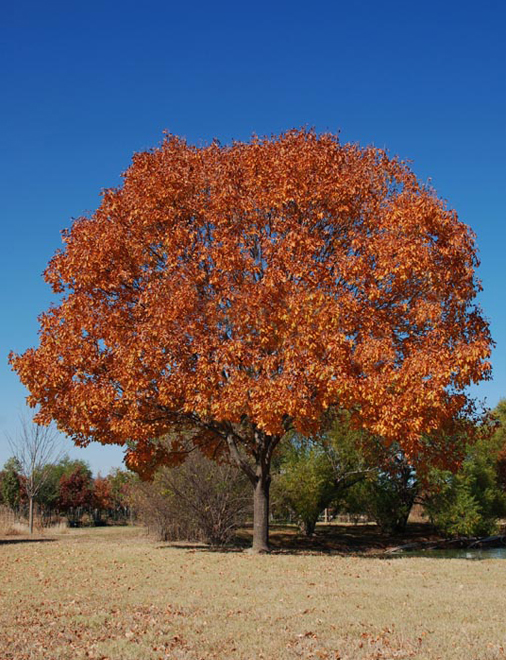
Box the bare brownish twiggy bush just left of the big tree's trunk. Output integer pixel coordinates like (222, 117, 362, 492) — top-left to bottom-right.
(130, 452, 251, 545)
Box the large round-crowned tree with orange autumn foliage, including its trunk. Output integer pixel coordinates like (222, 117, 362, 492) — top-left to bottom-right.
(10, 130, 490, 551)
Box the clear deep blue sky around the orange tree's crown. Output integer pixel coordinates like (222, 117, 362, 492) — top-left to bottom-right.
(0, 0, 506, 473)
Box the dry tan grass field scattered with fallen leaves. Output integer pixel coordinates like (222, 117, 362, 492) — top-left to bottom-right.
(0, 528, 506, 660)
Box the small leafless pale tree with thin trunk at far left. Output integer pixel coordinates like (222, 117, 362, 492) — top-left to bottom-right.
(8, 416, 61, 534)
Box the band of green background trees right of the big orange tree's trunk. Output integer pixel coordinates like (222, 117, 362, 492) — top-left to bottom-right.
(273, 402, 506, 536)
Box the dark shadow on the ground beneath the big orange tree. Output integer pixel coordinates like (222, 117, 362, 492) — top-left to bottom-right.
(158, 523, 440, 558)
